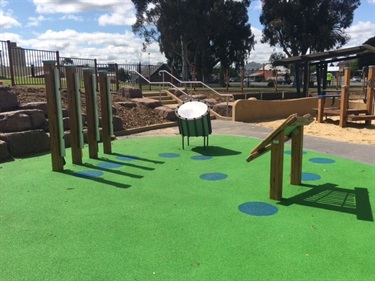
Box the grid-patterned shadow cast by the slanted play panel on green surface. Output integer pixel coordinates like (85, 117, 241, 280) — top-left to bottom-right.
(278, 183, 374, 222)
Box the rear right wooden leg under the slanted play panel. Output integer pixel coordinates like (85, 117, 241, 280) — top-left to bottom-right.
(290, 126, 303, 185)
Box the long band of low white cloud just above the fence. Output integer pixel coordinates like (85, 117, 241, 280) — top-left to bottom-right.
(0, 29, 166, 64)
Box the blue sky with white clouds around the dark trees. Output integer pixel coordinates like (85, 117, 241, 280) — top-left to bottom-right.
(0, 0, 375, 64)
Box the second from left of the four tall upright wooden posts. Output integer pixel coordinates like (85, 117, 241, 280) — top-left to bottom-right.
(65, 65, 83, 164)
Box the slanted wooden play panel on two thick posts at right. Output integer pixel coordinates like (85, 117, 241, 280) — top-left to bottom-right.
(246, 114, 313, 200)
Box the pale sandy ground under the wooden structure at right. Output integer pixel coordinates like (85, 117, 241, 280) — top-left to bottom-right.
(255, 117, 375, 145)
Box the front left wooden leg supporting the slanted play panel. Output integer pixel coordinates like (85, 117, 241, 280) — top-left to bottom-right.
(270, 130, 285, 200)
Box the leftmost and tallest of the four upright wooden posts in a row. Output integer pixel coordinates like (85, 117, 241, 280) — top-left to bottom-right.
(43, 61, 65, 172)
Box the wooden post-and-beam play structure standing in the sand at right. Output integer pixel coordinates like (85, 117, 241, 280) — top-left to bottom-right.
(317, 65, 375, 128)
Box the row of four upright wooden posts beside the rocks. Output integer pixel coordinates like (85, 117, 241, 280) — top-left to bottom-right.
(43, 61, 113, 171)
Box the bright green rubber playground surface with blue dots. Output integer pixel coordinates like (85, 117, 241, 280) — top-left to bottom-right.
(0, 135, 375, 281)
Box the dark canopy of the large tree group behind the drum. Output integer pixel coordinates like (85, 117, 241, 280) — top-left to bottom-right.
(132, 0, 254, 79)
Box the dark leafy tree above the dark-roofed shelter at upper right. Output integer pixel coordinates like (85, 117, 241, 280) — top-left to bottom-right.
(260, 0, 360, 57)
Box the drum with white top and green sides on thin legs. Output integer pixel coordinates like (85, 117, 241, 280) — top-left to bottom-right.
(175, 101, 212, 149)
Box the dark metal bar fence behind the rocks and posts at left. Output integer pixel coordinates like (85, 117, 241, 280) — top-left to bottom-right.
(0, 41, 159, 91)
